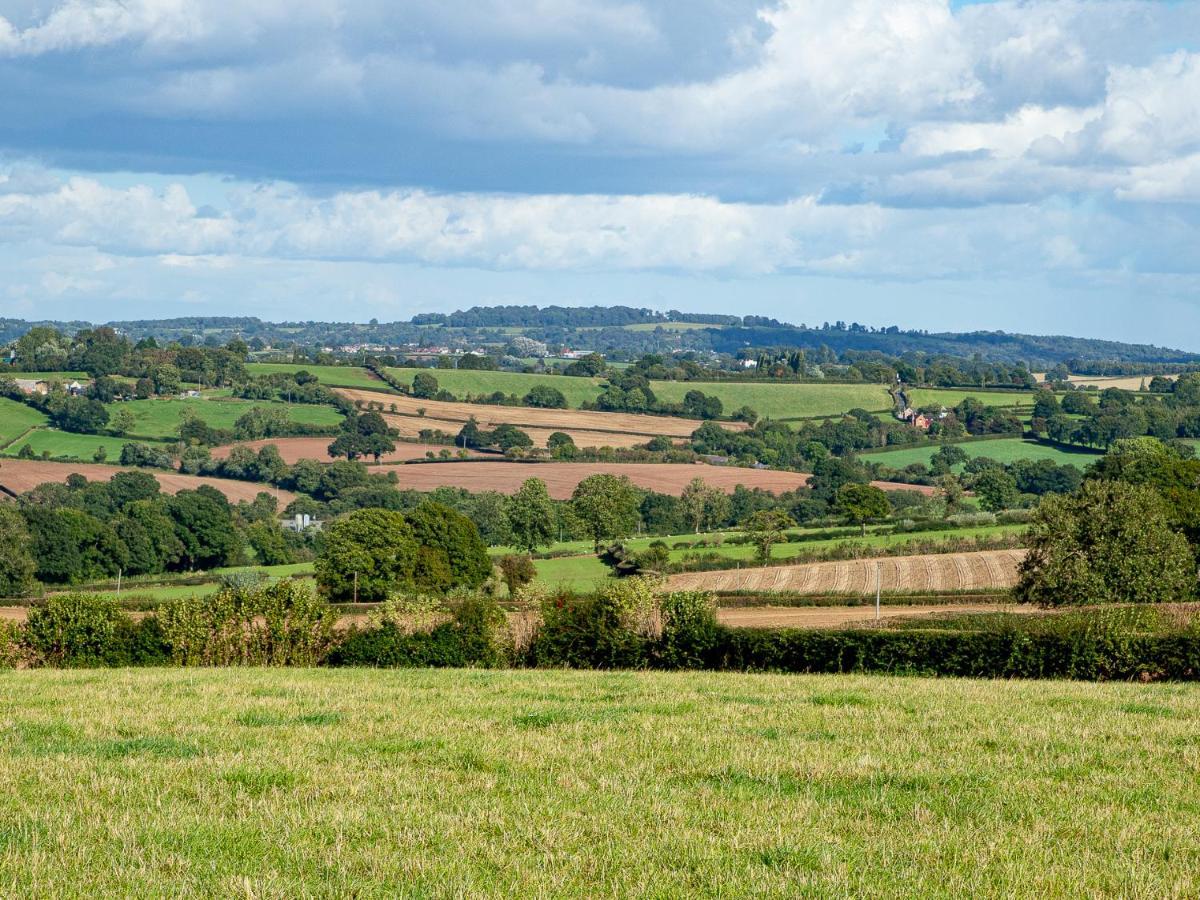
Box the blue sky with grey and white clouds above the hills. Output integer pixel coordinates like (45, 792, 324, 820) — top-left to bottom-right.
(0, 0, 1200, 350)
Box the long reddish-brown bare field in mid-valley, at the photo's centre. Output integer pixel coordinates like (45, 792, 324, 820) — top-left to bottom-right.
(384, 462, 932, 500)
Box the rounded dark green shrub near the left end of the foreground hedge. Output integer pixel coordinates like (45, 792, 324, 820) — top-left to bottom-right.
(25, 594, 125, 667)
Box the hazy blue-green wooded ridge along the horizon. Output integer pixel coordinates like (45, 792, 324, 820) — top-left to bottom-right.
(0, 306, 1200, 370)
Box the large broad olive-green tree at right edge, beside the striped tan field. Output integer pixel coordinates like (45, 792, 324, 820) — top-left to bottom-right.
(1016, 480, 1196, 606)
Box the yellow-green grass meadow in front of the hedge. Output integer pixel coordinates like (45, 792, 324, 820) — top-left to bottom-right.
(0, 670, 1200, 898)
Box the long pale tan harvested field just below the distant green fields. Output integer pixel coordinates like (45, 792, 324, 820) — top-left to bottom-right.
(337, 389, 746, 446)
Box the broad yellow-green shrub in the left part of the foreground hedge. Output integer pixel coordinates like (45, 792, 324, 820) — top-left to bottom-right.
(160, 580, 337, 666)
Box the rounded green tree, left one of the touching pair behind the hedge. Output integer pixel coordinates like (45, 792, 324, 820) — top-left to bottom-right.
(313, 509, 416, 601)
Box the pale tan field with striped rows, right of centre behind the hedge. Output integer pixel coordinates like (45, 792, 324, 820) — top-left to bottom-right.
(667, 550, 1025, 596)
